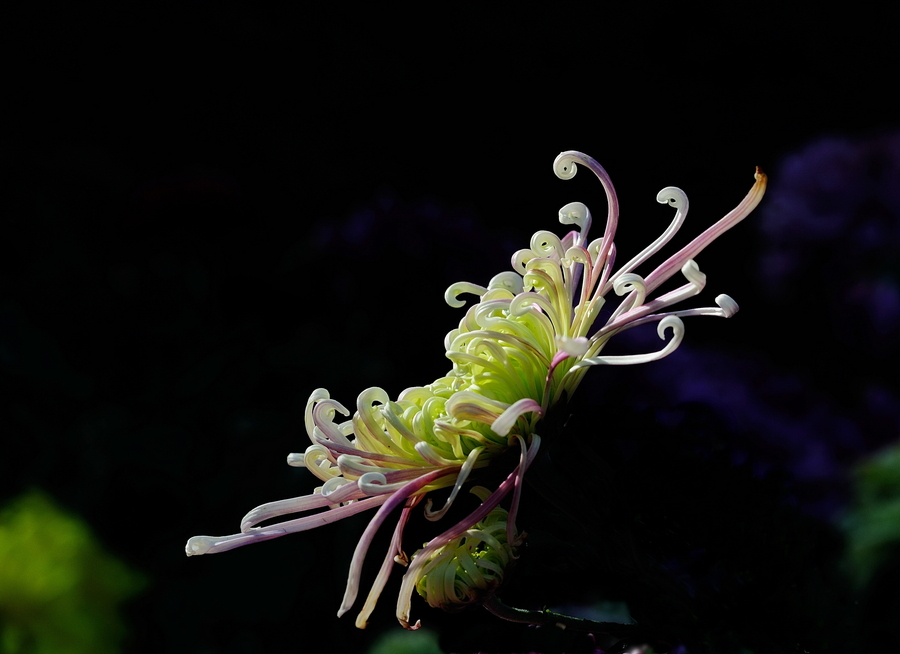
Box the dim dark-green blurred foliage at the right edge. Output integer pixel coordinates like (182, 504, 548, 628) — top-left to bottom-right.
(844, 444, 900, 587)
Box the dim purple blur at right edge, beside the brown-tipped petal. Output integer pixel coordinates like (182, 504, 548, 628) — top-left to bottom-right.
(759, 133, 900, 353)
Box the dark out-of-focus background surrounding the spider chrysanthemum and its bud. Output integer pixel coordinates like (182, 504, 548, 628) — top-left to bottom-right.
(0, 2, 900, 654)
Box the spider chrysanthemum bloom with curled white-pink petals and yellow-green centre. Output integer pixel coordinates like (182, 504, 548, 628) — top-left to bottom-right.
(186, 151, 766, 628)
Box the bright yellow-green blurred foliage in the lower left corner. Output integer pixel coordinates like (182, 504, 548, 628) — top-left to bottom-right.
(0, 490, 145, 654)
